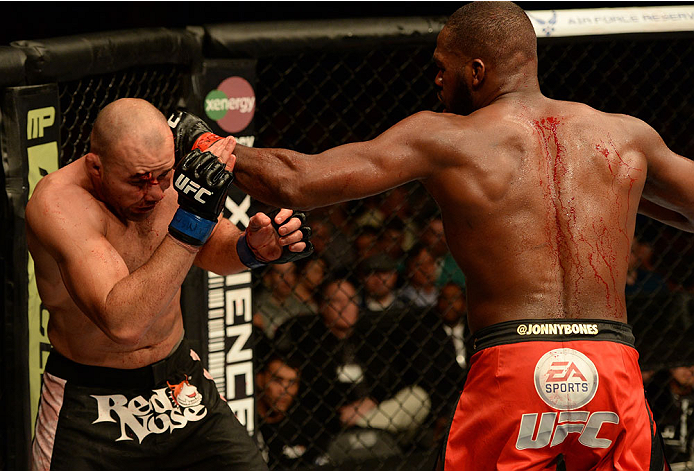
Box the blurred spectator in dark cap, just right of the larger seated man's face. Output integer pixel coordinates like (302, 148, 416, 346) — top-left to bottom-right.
(358, 253, 403, 314)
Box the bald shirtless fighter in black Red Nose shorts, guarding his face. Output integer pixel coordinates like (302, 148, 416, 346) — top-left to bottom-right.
(26, 99, 311, 471)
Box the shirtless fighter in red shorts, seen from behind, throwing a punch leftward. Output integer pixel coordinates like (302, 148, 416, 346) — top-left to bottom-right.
(174, 2, 694, 471)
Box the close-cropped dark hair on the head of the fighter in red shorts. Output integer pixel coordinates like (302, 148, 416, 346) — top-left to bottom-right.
(445, 1, 537, 68)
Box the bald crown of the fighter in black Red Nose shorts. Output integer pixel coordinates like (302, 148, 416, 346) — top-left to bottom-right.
(90, 98, 172, 167)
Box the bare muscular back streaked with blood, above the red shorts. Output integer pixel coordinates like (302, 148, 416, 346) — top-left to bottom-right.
(425, 99, 646, 331)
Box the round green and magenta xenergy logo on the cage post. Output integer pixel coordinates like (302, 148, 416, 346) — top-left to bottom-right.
(205, 77, 255, 133)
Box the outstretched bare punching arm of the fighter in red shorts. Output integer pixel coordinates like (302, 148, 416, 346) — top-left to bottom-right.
(234, 112, 442, 209)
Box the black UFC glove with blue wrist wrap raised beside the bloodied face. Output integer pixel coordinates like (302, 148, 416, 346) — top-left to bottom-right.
(169, 149, 234, 246)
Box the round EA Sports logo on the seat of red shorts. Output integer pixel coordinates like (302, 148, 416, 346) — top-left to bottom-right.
(535, 348, 598, 410)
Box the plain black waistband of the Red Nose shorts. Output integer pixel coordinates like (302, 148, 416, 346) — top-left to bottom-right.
(46, 339, 194, 389)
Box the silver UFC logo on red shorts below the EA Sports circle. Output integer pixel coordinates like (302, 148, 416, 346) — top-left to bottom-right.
(516, 411, 619, 450)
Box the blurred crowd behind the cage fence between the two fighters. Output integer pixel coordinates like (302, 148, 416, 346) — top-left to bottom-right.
(253, 187, 469, 469)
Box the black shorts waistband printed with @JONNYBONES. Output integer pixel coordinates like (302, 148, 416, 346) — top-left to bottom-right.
(473, 319, 634, 352)
